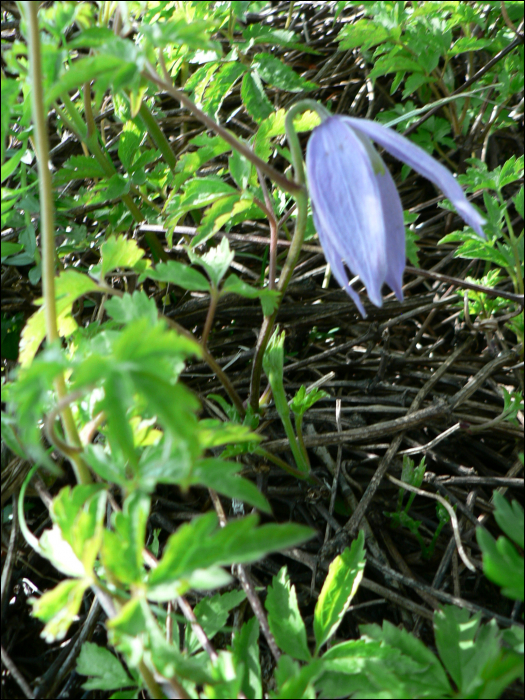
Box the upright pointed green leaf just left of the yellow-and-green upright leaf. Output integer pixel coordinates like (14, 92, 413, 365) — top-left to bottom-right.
(265, 567, 312, 661)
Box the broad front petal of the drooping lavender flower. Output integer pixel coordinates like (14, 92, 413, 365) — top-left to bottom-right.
(306, 117, 388, 313)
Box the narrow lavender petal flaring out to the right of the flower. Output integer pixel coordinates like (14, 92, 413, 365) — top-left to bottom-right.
(340, 117, 486, 238)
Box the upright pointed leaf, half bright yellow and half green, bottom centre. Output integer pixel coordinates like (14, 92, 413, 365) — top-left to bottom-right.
(314, 530, 365, 654)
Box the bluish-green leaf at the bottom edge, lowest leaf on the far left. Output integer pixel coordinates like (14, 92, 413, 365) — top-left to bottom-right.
(76, 642, 135, 690)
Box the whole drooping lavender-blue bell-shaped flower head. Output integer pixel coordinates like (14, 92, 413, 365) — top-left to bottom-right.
(306, 116, 485, 318)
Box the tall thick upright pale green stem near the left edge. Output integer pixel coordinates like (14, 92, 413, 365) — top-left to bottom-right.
(24, 2, 92, 484)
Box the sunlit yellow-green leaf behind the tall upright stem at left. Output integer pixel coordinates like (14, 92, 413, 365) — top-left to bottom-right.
(19, 269, 98, 367)
